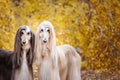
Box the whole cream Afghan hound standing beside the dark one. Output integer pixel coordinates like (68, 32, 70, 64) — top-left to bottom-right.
(35, 21, 81, 80)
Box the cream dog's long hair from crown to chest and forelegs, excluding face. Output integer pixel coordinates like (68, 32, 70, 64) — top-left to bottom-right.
(35, 22, 60, 80)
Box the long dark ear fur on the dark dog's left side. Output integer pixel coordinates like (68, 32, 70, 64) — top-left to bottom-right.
(13, 29, 22, 67)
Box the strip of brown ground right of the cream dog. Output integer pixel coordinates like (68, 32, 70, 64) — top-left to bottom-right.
(81, 70, 120, 80)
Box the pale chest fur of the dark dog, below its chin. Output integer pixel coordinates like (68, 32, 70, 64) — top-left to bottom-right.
(15, 52, 32, 80)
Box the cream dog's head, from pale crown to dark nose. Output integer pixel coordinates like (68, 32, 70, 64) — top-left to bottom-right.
(37, 21, 56, 43)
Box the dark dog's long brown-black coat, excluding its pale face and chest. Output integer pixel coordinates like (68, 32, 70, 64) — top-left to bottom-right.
(0, 26, 35, 80)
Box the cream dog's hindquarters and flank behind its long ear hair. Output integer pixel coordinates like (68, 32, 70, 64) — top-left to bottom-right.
(57, 45, 81, 80)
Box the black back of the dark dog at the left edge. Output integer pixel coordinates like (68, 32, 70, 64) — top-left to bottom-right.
(0, 49, 13, 80)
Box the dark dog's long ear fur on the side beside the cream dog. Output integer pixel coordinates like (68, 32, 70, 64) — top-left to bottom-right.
(27, 31, 35, 66)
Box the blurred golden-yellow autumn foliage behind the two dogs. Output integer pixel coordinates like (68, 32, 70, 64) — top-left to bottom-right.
(0, 0, 120, 72)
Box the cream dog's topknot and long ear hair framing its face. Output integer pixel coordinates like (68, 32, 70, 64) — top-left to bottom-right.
(35, 22, 58, 66)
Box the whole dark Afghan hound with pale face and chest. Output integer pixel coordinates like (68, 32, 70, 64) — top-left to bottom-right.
(0, 26, 35, 80)
